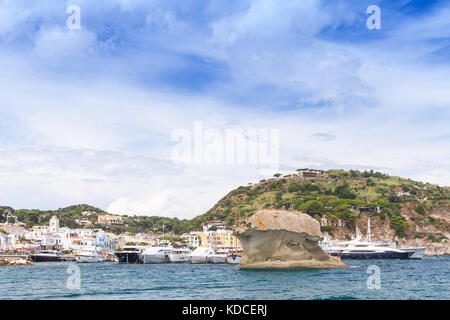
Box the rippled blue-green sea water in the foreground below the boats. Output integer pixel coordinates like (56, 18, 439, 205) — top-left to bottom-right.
(0, 256, 450, 300)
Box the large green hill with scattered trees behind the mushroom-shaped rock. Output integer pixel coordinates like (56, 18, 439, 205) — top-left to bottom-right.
(188, 170, 450, 239)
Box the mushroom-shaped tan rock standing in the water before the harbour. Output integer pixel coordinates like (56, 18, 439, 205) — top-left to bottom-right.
(237, 210, 347, 269)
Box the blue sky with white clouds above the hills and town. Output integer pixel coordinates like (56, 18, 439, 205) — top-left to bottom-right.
(0, 0, 450, 218)
